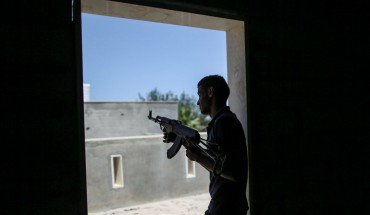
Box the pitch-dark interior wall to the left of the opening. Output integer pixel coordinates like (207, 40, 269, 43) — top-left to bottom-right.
(0, 1, 87, 215)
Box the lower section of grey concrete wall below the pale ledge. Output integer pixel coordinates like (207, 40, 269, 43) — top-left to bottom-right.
(86, 135, 209, 212)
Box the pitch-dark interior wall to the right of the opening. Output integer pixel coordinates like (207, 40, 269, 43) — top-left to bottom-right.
(248, 1, 369, 215)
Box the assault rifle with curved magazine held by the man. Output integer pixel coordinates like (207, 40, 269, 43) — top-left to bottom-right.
(148, 110, 226, 174)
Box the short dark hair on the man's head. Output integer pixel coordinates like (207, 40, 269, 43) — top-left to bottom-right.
(198, 75, 230, 103)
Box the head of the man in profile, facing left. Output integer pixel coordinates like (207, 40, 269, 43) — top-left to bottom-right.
(197, 75, 230, 114)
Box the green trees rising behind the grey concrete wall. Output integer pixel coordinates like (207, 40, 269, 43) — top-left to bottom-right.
(139, 88, 209, 131)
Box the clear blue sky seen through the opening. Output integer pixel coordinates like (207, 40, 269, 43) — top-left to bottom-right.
(82, 14, 227, 101)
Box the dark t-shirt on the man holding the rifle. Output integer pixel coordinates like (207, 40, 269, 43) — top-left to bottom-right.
(206, 107, 249, 215)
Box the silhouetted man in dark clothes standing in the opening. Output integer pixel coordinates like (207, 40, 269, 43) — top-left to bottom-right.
(165, 75, 249, 215)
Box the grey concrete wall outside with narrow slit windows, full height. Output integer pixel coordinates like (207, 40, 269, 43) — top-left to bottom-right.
(85, 102, 209, 212)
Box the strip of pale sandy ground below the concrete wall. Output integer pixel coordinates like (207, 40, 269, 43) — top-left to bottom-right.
(89, 193, 210, 215)
